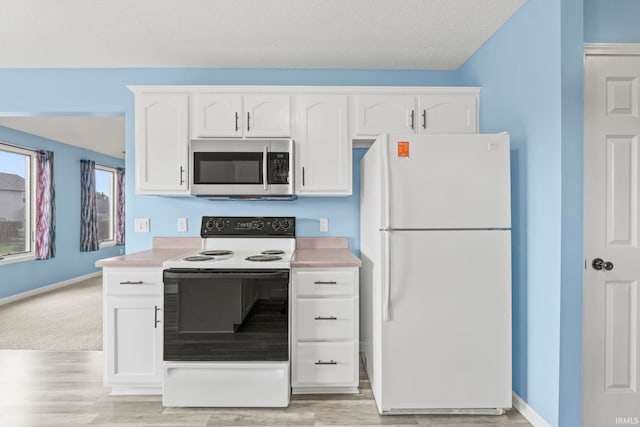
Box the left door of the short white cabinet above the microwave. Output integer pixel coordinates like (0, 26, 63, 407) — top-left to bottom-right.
(191, 93, 243, 138)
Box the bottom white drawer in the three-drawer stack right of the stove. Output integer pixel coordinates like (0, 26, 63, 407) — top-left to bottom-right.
(294, 342, 358, 386)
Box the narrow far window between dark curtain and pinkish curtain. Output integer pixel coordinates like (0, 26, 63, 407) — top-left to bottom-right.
(96, 165, 118, 246)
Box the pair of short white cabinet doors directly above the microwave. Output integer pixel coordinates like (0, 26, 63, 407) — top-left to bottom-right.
(191, 92, 291, 138)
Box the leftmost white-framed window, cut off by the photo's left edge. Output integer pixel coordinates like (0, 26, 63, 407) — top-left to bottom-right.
(0, 143, 35, 262)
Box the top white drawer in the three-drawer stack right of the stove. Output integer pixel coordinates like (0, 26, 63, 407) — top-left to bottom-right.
(294, 269, 356, 296)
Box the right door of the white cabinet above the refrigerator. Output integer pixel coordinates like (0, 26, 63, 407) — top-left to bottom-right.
(417, 94, 478, 133)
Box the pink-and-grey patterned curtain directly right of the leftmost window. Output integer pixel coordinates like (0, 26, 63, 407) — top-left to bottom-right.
(35, 151, 56, 259)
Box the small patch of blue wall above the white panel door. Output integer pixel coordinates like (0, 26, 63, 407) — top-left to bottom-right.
(584, 0, 640, 43)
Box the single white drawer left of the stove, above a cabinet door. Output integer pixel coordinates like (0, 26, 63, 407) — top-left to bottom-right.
(103, 268, 163, 295)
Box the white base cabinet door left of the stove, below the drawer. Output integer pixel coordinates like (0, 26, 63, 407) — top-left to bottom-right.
(103, 297, 163, 386)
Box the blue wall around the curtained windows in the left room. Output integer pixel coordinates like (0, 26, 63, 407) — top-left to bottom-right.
(0, 126, 124, 298)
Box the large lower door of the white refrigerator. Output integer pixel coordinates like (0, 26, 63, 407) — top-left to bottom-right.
(381, 230, 512, 411)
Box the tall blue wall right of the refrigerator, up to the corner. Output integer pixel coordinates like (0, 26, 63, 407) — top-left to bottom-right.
(460, 0, 564, 425)
